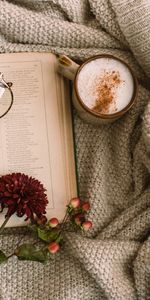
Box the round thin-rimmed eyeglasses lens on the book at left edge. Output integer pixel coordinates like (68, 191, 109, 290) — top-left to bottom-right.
(0, 72, 14, 118)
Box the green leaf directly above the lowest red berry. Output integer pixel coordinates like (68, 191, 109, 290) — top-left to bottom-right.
(38, 228, 59, 243)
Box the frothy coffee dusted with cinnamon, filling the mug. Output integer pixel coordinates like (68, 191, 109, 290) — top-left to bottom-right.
(77, 57, 134, 114)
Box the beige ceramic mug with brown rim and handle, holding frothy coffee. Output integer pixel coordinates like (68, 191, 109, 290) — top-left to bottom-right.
(58, 54, 138, 124)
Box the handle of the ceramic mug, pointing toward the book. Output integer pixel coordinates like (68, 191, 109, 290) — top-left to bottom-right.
(58, 55, 79, 80)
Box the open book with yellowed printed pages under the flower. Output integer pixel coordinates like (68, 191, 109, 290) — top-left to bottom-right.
(0, 53, 77, 226)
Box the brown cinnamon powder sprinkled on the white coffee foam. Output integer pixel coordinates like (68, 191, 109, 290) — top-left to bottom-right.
(92, 71, 122, 114)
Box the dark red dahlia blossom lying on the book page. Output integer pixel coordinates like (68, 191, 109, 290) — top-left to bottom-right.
(0, 173, 48, 220)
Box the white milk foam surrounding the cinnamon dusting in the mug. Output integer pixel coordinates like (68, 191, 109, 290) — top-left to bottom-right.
(77, 58, 134, 114)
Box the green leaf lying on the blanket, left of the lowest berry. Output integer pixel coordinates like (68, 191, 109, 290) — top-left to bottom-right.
(16, 244, 48, 263)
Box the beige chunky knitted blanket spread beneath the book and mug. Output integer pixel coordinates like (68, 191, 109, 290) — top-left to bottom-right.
(0, 0, 150, 300)
